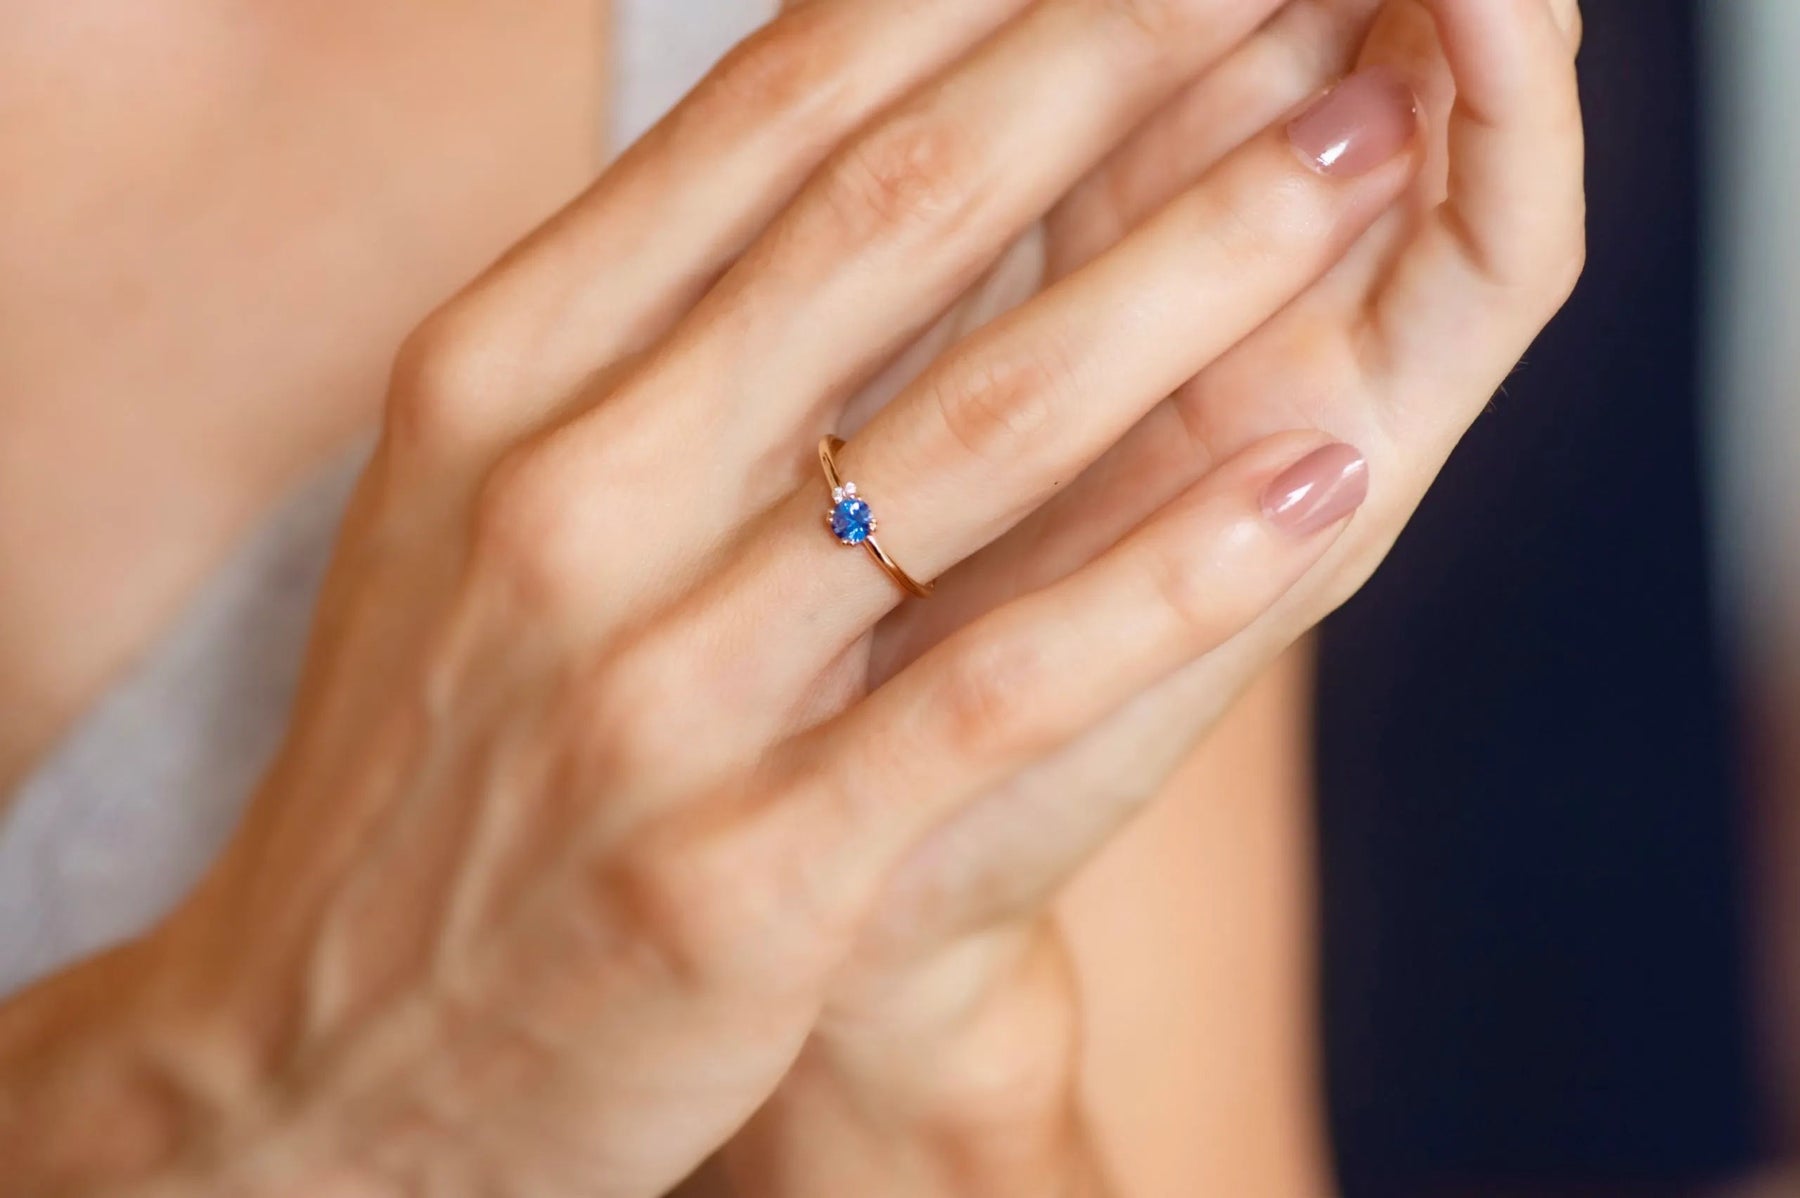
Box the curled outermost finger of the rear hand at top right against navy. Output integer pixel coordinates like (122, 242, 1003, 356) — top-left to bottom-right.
(1372, 0, 1584, 406)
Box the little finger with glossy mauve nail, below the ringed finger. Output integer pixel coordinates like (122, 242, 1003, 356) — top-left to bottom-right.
(794, 434, 1368, 910)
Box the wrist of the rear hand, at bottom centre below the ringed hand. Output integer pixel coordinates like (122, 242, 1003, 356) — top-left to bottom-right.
(724, 925, 1098, 1198)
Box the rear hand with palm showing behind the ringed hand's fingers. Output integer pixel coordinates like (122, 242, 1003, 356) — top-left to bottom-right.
(709, 0, 1582, 1193)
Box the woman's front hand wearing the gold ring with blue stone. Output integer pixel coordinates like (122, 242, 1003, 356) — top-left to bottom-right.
(0, 0, 1566, 1196)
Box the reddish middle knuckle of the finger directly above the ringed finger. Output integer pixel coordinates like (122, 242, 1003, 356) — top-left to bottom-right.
(823, 113, 981, 241)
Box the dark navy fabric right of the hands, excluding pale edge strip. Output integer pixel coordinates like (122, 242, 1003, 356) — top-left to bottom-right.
(1318, 0, 1757, 1198)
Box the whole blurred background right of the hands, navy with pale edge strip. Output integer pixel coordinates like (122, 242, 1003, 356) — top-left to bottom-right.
(1318, 0, 1800, 1198)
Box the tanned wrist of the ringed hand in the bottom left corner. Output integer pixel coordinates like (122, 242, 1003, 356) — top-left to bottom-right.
(0, 906, 389, 1198)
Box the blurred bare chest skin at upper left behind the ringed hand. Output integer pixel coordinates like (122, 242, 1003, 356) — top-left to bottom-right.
(0, 0, 603, 791)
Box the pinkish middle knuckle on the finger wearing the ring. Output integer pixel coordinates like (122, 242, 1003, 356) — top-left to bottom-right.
(925, 347, 1073, 466)
